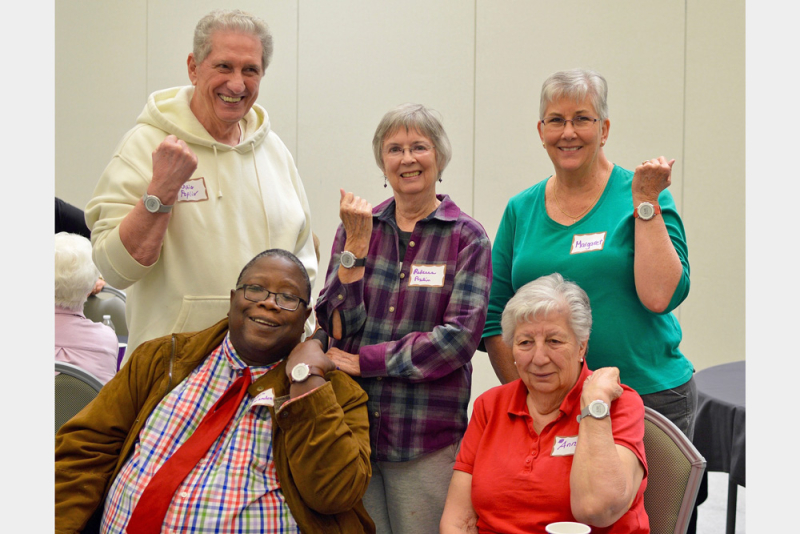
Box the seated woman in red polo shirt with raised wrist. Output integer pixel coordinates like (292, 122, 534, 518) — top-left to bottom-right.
(440, 273, 650, 534)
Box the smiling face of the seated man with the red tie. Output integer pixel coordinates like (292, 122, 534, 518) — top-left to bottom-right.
(228, 256, 311, 365)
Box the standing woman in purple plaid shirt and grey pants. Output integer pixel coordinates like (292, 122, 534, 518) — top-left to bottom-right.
(316, 104, 492, 534)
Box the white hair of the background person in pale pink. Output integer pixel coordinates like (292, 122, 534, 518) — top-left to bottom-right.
(55, 232, 100, 311)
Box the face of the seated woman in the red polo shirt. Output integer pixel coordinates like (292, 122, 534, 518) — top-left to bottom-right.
(511, 313, 588, 399)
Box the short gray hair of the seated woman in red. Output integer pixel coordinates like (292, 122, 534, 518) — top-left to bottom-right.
(500, 273, 592, 346)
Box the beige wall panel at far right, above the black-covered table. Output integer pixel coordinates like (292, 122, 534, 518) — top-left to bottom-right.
(681, 0, 745, 371)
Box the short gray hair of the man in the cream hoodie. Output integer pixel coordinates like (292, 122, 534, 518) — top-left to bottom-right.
(192, 9, 272, 70)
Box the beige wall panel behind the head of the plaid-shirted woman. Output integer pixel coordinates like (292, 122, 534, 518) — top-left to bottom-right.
(297, 0, 474, 294)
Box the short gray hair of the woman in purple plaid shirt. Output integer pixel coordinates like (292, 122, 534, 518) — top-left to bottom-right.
(372, 104, 453, 178)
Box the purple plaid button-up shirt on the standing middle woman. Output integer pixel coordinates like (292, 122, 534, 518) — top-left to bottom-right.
(316, 195, 492, 462)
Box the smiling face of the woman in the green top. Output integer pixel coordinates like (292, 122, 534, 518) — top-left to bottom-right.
(538, 97, 611, 174)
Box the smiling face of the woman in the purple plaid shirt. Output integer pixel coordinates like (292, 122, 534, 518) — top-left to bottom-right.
(381, 128, 439, 202)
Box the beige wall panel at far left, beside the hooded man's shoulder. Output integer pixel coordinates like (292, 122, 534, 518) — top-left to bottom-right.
(54, 0, 147, 209)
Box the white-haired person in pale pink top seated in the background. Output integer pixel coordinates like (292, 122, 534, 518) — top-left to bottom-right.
(55, 232, 119, 384)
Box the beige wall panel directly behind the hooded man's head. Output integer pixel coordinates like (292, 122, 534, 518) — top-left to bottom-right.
(145, 0, 297, 154)
